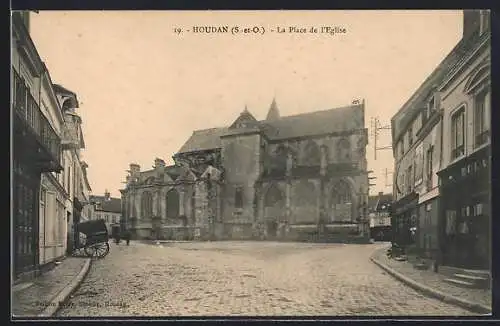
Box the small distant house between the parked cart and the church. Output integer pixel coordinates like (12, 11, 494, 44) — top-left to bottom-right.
(90, 191, 122, 234)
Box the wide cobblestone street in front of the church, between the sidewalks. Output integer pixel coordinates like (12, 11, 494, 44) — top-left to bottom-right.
(58, 242, 473, 316)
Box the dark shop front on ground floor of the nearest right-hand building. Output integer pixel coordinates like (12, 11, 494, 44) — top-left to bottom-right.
(438, 146, 491, 269)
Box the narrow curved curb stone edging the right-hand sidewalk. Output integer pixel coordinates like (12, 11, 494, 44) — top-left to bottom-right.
(370, 251, 491, 314)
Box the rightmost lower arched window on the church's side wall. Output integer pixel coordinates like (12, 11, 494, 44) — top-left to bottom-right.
(330, 180, 355, 222)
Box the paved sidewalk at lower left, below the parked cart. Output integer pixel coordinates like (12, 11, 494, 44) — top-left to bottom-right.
(11, 257, 91, 318)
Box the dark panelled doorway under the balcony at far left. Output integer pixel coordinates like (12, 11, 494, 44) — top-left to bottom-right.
(13, 162, 40, 277)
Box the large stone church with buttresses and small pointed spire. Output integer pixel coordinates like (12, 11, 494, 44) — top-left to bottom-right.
(121, 100, 368, 240)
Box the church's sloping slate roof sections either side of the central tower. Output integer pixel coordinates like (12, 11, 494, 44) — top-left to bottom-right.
(178, 104, 365, 153)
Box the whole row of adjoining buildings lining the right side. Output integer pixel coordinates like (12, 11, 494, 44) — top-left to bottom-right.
(391, 10, 491, 268)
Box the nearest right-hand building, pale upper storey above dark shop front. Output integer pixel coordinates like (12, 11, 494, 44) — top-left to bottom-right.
(438, 10, 491, 269)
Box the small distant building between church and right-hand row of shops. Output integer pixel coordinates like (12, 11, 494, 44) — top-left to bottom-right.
(368, 192, 392, 241)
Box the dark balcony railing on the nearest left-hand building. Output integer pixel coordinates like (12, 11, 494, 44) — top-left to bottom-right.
(12, 69, 61, 171)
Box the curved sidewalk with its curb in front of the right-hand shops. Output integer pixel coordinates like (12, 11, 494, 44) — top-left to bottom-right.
(371, 248, 492, 314)
